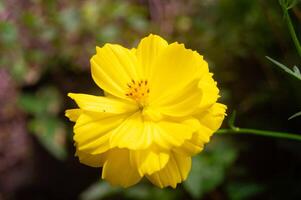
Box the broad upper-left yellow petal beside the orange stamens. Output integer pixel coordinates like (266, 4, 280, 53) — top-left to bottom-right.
(90, 44, 142, 99)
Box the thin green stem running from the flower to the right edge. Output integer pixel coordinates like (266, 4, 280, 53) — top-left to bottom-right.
(217, 127, 301, 141)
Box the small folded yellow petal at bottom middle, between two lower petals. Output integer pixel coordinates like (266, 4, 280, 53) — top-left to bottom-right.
(130, 146, 169, 176)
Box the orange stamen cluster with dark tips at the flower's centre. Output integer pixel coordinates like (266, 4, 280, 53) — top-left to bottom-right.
(125, 80, 149, 107)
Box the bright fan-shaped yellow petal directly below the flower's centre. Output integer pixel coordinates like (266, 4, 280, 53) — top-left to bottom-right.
(110, 112, 152, 150)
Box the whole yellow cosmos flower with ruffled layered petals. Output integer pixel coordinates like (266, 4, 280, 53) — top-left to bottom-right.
(66, 34, 226, 188)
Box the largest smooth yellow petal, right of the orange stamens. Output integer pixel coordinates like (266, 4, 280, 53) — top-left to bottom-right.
(149, 43, 209, 117)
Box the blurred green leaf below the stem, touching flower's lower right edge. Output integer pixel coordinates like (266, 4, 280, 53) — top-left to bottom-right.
(184, 138, 237, 199)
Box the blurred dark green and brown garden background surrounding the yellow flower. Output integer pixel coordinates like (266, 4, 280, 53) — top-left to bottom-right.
(0, 0, 301, 200)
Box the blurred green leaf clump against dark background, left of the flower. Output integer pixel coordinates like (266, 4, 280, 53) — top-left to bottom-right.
(19, 86, 67, 160)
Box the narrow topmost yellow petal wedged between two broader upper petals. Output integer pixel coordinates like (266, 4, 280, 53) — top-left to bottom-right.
(136, 34, 168, 78)
